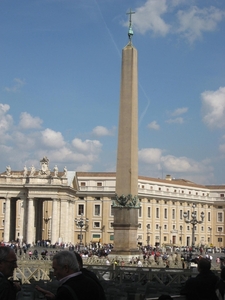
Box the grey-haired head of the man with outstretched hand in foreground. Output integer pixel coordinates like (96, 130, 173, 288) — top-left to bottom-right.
(52, 251, 79, 280)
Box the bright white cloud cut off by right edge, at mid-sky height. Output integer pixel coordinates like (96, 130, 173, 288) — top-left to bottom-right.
(201, 87, 225, 128)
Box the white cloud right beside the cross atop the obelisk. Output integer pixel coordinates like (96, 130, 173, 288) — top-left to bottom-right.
(133, 0, 170, 36)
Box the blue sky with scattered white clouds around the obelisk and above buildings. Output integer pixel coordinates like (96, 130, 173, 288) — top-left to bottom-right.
(0, 0, 225, 184)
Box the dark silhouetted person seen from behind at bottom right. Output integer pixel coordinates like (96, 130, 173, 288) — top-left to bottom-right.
(180, 258, 219, 300)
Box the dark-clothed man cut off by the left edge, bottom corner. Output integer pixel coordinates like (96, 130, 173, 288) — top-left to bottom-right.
(0, 246, 21, 300)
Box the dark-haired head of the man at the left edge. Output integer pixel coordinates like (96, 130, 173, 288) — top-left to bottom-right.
(0, 247, 17, 278)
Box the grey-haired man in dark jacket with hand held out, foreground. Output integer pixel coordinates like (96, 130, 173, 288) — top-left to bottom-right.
(36, 250, 104, 300)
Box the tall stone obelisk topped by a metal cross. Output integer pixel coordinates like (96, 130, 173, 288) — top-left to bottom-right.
(113, 11, 140, 257)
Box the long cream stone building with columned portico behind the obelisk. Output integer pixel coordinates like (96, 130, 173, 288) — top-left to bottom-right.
(0, 157, 225, 247)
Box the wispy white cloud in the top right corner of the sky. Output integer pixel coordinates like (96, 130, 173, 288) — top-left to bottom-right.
(177, 6, 225, 43)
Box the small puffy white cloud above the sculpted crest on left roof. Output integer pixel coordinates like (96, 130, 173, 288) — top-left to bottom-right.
(41, 128, 65, 149)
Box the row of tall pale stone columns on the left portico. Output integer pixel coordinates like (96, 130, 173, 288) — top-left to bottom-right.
(4, 198, 75, 245)
